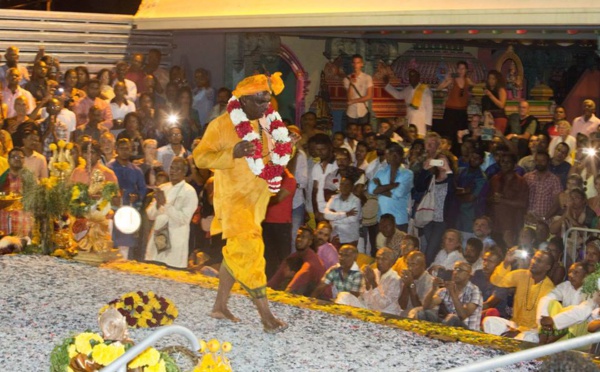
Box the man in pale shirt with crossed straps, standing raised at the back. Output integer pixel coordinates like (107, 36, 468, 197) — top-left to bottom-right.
(344, 54, 373, 125)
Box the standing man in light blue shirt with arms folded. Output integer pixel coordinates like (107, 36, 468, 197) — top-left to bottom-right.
(368, 143, 413, 232)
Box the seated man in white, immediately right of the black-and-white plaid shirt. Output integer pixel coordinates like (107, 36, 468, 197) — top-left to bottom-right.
(336, 248, 400, 315)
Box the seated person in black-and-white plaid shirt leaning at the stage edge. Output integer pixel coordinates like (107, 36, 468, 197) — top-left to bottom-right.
(311, 244, 365, 302)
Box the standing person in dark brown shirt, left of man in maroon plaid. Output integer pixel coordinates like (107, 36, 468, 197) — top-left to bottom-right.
(488, 153, 537, 244)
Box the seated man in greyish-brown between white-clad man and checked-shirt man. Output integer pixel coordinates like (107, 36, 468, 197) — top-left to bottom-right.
(398, 251, 433, 317)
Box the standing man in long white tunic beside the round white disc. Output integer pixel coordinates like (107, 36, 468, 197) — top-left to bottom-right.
(145, 159, 198, 268)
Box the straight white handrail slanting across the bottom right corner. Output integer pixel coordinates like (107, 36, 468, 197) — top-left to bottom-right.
(447, 332, 600, 372)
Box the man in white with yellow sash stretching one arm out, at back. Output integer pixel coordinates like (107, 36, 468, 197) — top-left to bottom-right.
(385, 69, 433, 136)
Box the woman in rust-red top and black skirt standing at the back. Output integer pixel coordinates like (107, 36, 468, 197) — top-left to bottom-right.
(433, 61, 473, 156)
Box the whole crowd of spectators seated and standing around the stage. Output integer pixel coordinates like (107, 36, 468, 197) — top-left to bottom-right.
(0, 46, 600, 343)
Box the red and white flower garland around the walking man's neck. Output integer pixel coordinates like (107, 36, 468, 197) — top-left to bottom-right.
(227, 96, 293, 193)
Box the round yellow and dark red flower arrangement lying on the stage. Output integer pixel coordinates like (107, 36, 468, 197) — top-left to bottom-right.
(99, 291, 179, 328)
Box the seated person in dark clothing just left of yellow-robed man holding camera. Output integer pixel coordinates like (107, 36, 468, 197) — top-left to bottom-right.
(471, 250, 508, 319)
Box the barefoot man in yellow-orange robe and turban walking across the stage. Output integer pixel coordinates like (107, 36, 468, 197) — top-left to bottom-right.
(193, 73, 291, 333)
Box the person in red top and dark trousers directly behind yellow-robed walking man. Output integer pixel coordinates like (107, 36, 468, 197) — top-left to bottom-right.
(262, 169, 296, 278)
